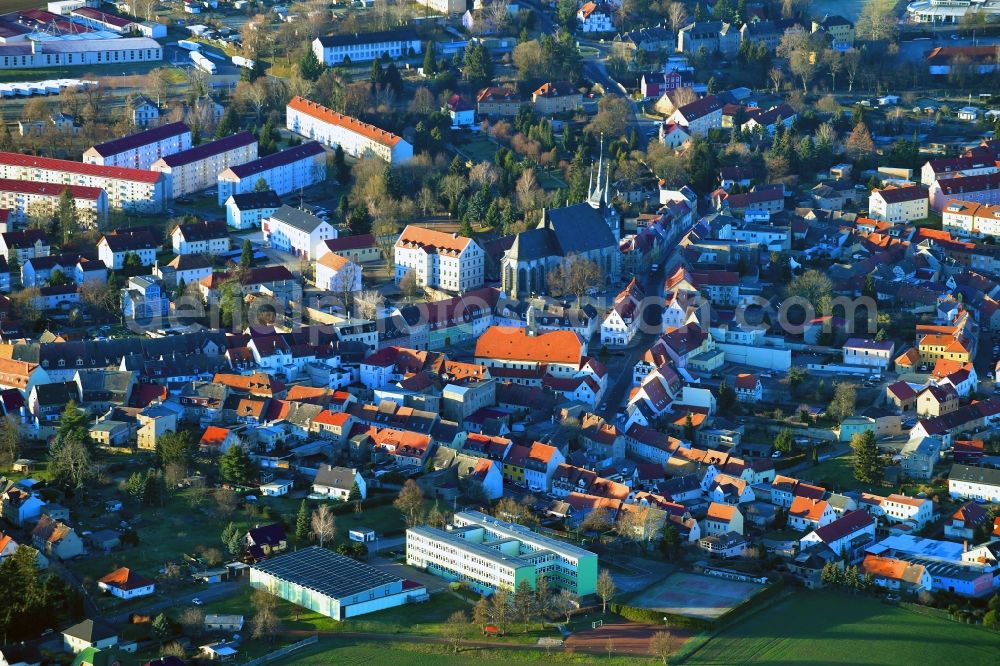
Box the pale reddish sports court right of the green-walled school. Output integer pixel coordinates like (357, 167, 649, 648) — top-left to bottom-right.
(629, 572, 764, 620)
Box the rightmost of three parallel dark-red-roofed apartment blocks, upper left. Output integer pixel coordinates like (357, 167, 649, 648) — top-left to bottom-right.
(218, 141, 326, 206)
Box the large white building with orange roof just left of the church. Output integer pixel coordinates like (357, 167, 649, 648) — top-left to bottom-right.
(393, 224, 486, 292)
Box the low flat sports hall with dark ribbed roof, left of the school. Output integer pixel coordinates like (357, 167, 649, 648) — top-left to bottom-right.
(250, 546, 428, 621)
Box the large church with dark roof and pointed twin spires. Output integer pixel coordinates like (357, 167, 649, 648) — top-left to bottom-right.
(500, 150, 621, 298)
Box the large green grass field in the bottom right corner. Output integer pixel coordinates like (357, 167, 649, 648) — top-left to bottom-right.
(685, 592, 1000, 666)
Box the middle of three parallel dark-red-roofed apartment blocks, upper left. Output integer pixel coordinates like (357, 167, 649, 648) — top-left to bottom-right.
(150, 131, 257, 199)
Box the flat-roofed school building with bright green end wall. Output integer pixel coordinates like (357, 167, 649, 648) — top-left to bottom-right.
(406, 511, 597, 597)
